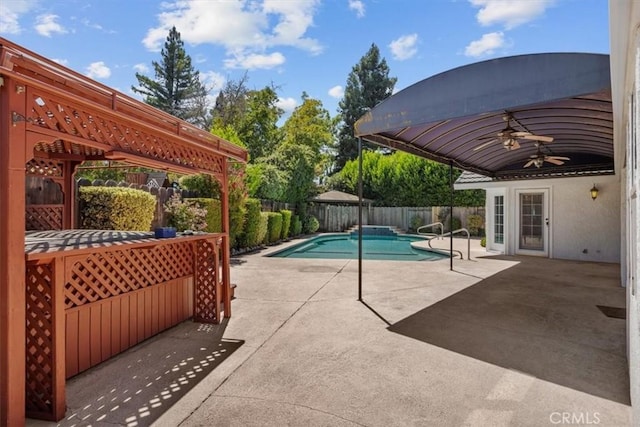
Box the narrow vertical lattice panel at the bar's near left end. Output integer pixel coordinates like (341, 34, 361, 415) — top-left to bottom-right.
(26, 264, 55, 413)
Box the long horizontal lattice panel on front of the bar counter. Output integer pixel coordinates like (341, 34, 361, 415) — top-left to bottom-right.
(65, 242, 193, 308)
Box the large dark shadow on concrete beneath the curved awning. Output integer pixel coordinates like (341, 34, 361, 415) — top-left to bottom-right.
(389, 256, 630, 405)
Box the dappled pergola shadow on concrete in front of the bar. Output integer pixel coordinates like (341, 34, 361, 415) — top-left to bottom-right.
(40, 320, 244, 427)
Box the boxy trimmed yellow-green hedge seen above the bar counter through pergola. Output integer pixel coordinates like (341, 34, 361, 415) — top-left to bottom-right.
(79, 187, 156, 231)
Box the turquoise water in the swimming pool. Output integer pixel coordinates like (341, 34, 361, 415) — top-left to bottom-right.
(270, 233, 449, 261)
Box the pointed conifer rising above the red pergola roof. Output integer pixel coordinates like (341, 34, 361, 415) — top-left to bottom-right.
(131, 27, 208, 128)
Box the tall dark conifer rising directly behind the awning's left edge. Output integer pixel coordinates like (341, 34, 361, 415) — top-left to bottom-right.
(336, 43, 398, 170)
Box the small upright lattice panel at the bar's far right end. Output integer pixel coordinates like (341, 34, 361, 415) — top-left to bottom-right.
(193, 240, 222, 323)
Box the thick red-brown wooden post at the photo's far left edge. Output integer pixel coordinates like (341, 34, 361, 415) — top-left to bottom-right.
(0, 76, 26, 426)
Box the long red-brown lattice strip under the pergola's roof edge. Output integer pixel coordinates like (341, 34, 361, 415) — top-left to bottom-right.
(27, 93, 224, 174)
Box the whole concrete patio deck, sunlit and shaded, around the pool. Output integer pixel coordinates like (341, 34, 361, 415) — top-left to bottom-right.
(29, 237, 631, 426)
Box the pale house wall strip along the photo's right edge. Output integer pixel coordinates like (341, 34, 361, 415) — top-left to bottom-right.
(609, 0, 640, 426)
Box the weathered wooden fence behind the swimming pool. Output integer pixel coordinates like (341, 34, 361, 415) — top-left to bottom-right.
(309, 203, 485, 232)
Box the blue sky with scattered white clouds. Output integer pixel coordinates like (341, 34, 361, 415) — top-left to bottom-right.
(0, 0, 609, 117)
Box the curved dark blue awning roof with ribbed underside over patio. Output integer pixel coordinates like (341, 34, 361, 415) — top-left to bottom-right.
(355, 53, 614, 179)
